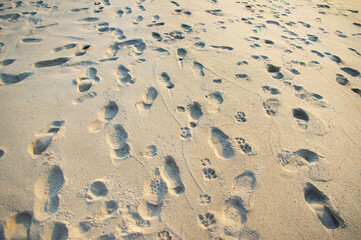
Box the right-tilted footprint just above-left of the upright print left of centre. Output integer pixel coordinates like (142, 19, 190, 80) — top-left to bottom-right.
(88, 101, 118, 132)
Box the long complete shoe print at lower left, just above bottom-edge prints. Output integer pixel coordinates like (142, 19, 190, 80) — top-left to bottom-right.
(34, 165, 65, 220)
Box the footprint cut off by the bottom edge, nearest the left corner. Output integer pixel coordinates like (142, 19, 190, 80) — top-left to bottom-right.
(4, 211, 33, 240)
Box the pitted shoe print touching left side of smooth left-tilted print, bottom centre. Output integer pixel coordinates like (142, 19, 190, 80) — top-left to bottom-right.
(138, 168, 168, 219)
